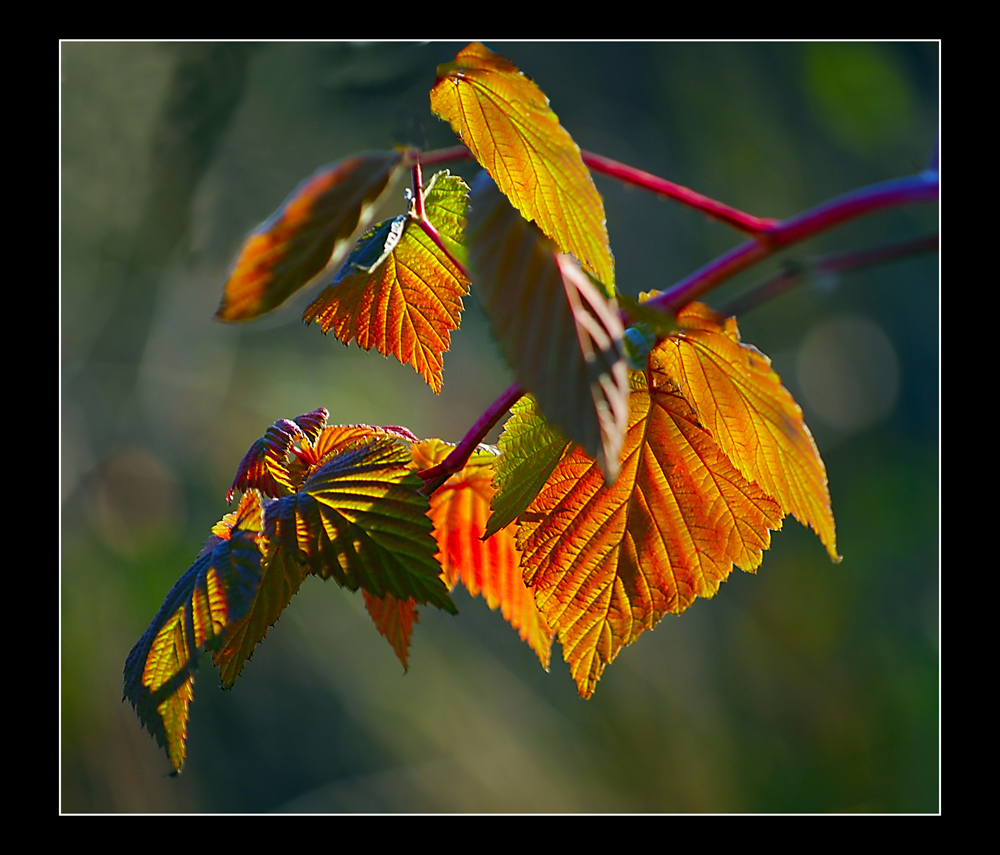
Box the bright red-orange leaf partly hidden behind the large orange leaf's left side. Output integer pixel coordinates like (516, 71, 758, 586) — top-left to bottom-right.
(412, 439, 552, 669)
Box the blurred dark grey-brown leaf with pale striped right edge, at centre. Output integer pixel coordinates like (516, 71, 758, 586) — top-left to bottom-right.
(469, 173, 628, 479)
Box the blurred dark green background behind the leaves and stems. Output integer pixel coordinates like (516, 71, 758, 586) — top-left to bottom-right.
(60, 42, 940, 812)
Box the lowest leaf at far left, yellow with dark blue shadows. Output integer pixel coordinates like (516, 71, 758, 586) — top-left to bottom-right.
(125, 492, 261, 772)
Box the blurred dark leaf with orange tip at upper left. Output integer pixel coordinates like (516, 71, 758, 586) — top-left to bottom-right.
(215, 151, 403, 321)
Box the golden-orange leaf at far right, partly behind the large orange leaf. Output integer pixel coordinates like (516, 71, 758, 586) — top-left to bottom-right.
(652, 303, 840, 561)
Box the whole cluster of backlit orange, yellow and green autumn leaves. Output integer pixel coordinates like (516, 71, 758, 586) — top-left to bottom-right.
(125, 44, 838, 771)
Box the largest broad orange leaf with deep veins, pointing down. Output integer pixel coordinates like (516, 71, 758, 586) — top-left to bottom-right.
(517, 374, 782, 697)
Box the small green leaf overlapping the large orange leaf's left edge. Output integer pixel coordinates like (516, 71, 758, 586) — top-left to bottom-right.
(483, 395, 570, 537)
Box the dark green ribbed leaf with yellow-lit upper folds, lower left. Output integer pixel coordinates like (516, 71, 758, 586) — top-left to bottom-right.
(268, 435, 456, 612)
